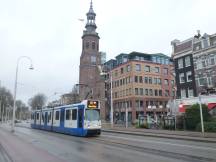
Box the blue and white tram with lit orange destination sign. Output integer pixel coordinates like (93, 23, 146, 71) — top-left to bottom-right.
(31, 100, 101, 136)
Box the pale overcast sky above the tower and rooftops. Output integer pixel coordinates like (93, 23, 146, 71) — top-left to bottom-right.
(0, 0, 216, 102)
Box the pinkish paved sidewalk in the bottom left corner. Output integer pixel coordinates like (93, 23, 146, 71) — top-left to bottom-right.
(0, 125, 64, 162)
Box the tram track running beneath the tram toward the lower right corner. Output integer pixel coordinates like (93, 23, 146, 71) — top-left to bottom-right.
(14, 126, 216, 162)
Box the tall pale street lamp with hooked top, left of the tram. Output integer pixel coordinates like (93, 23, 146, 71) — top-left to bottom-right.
(11, 56, 34, 132)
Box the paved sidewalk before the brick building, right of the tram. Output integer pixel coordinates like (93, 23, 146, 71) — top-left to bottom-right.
(102, 123, 216, 143)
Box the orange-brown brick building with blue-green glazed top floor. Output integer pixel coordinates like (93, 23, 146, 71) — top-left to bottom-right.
(105, 52, 175, 122)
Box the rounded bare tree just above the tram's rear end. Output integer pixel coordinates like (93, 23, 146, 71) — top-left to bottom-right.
(28, 93, 47, 110)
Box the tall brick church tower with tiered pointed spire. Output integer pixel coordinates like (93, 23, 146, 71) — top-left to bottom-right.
(79, 1, 102, 100)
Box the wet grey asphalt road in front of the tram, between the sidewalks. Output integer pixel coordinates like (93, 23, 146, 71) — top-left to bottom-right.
(1, 123, 216, 162)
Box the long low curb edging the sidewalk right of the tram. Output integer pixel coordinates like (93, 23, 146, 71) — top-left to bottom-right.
(102, 129, 216, 143)
